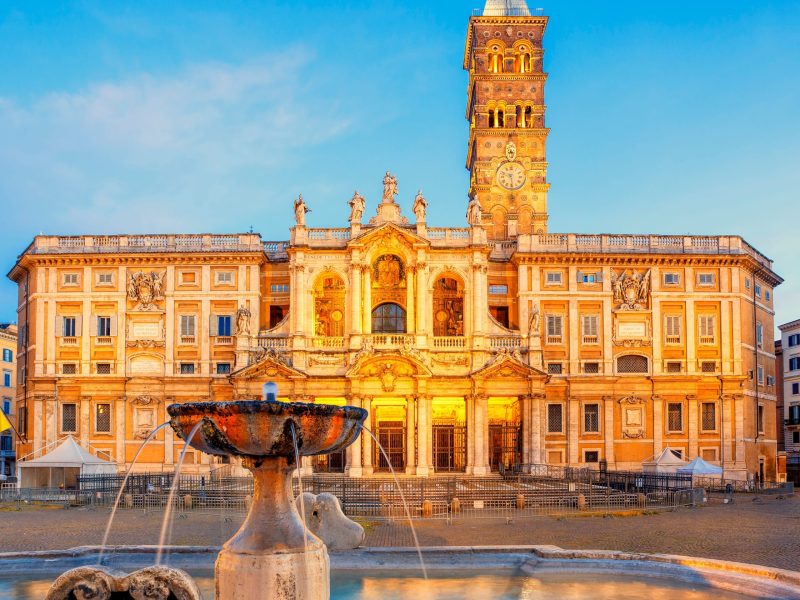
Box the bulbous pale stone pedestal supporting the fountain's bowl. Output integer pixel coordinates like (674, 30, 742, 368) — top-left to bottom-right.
(215, 456, 330, 600)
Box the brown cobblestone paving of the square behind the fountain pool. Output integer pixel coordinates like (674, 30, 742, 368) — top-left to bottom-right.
(0, 495, 800, 570)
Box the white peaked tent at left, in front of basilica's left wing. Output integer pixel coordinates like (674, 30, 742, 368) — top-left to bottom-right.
(17, 436, 117, 489)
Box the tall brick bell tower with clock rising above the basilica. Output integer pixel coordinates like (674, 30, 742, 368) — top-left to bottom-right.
(464, 0, 550, 240)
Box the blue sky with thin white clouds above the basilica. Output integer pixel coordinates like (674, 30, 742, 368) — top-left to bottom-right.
(0, 0, 800, 330)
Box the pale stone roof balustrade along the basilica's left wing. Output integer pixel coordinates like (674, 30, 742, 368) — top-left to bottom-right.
(27, 233, 263, 254)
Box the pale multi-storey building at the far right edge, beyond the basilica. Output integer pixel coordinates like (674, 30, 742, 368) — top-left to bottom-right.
(776, 320, 800, 485)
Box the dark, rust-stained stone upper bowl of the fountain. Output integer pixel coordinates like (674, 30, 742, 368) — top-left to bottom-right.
(167, 400, 367, 462)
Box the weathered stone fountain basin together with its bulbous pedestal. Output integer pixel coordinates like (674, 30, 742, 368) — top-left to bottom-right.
(167, 383, 367, 600)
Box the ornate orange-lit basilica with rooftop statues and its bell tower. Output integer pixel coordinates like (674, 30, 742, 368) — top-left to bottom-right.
(9, 0, 781, 480)
